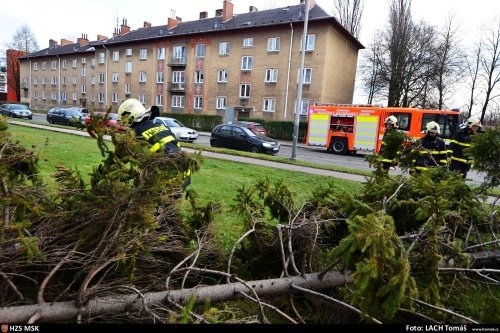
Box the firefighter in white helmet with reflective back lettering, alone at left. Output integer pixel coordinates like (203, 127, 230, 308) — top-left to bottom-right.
(118, 98, 191, 192)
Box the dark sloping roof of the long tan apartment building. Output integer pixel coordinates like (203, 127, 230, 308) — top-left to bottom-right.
(20, 5, 365, 59)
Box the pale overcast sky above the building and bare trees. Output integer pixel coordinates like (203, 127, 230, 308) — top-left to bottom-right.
(0, 0, 500, 103)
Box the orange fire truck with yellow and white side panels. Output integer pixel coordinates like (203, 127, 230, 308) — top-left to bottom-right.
(306, 104, 459, 154)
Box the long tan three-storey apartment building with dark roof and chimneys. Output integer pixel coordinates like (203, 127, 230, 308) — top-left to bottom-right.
(20, 0, 364, 120)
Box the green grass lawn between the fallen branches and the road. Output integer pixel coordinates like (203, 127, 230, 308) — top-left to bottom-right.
(5, 125, 362, 250)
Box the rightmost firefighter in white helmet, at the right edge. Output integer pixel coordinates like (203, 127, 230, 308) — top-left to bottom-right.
(448, 117, 482, 179)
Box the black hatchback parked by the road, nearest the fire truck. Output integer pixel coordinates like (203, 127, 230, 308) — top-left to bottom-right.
(210, 124, 280, 154)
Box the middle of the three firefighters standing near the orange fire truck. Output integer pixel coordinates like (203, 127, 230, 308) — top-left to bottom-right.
(412, 121, 448, 172)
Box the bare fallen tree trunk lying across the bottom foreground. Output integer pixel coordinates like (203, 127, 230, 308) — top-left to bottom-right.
(0, 272, 352, 323)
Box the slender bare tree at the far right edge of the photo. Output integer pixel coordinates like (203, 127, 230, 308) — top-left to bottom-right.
(481, 21, 500, 121)
